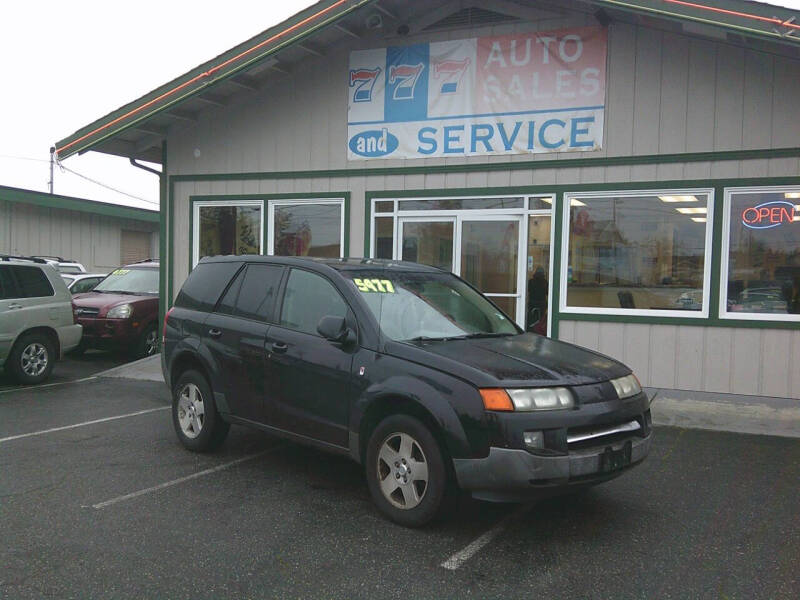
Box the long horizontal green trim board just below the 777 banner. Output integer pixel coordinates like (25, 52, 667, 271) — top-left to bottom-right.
(167, 148, 800, 181)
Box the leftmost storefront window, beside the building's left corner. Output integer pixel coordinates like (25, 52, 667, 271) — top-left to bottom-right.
(196, 204, 262, 260)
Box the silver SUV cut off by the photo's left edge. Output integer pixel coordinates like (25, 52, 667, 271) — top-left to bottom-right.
(0, 255, 81, 384)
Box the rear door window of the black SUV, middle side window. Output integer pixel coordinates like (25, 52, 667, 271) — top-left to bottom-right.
(217, 264, 283, 322)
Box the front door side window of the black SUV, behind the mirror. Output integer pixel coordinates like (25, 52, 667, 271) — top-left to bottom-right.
(280, 269, 347, 335)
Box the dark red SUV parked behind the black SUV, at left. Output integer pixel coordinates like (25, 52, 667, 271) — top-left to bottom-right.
(73, 260, 159, 357)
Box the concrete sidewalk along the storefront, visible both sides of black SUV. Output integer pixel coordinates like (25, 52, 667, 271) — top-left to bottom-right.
(97, 355, 800, 438)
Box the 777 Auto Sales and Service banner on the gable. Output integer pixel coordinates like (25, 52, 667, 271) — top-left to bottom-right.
(347, 27, 607, 160)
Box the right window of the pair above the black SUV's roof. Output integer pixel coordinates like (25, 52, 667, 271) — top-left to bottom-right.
(273, 202, 342, 258)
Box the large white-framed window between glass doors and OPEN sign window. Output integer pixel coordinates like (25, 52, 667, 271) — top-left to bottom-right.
(563, 191, 711, 316)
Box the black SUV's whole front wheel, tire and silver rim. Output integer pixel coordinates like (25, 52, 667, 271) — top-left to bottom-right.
(366, 415, 452, 527)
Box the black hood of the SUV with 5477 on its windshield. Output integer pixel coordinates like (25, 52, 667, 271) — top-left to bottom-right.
(387, 333, 631, 387)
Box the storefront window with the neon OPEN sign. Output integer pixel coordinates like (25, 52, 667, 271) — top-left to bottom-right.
(720, 188, 800, 320)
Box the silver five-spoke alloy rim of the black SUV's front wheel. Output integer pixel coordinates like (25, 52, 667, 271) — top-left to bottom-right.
(377, 432, 428, 510)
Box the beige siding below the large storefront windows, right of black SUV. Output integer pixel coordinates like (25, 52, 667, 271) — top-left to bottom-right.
(559, 321, 800, 399)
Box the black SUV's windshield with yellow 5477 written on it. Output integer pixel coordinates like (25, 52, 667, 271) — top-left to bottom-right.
(345, 271, 520, 341)
